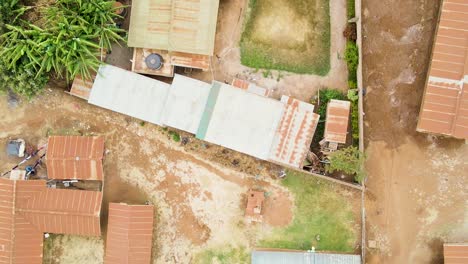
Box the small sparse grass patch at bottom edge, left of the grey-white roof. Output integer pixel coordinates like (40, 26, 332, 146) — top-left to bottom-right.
(193, 246, 250, 264)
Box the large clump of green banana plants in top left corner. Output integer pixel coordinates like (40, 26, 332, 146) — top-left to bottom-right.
(0, 0, 123, 96)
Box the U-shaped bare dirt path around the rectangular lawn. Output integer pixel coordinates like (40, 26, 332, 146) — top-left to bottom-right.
(185, 0, 348, 101)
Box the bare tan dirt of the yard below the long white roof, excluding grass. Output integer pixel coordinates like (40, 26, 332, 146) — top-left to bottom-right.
(0, 89, 293, 263)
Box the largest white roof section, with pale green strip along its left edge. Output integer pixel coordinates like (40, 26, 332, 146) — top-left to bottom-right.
(197, 82, 284, 160)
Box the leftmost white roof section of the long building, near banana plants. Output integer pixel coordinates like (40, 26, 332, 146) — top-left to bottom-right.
(88, 64, 170, 125)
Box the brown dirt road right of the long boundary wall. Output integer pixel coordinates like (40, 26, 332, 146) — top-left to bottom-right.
(362, 0, 468, 263)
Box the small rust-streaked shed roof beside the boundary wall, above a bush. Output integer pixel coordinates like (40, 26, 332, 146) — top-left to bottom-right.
(324, 100, 351, 144)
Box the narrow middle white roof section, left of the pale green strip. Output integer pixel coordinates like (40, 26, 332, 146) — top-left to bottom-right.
(162, 74, 211, 134)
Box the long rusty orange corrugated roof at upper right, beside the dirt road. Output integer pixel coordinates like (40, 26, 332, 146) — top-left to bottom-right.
(417, 0, 468, 139)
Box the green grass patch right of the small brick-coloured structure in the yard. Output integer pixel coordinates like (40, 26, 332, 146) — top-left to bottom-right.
(257, 171, 357, 252)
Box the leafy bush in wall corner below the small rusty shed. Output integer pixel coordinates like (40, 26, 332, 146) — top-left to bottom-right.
(325, 146, 366, 183)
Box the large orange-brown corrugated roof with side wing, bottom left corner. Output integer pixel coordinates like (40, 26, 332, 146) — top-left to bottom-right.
(0, 179, 102, 264)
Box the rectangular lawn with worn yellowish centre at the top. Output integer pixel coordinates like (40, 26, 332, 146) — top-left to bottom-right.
(240, 0, 330, 76)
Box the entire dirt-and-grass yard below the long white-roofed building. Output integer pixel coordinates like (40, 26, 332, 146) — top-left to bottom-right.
(0, 87, 360, 264)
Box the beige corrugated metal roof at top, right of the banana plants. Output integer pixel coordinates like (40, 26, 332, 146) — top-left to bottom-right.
(128, 0, 219, 55)
